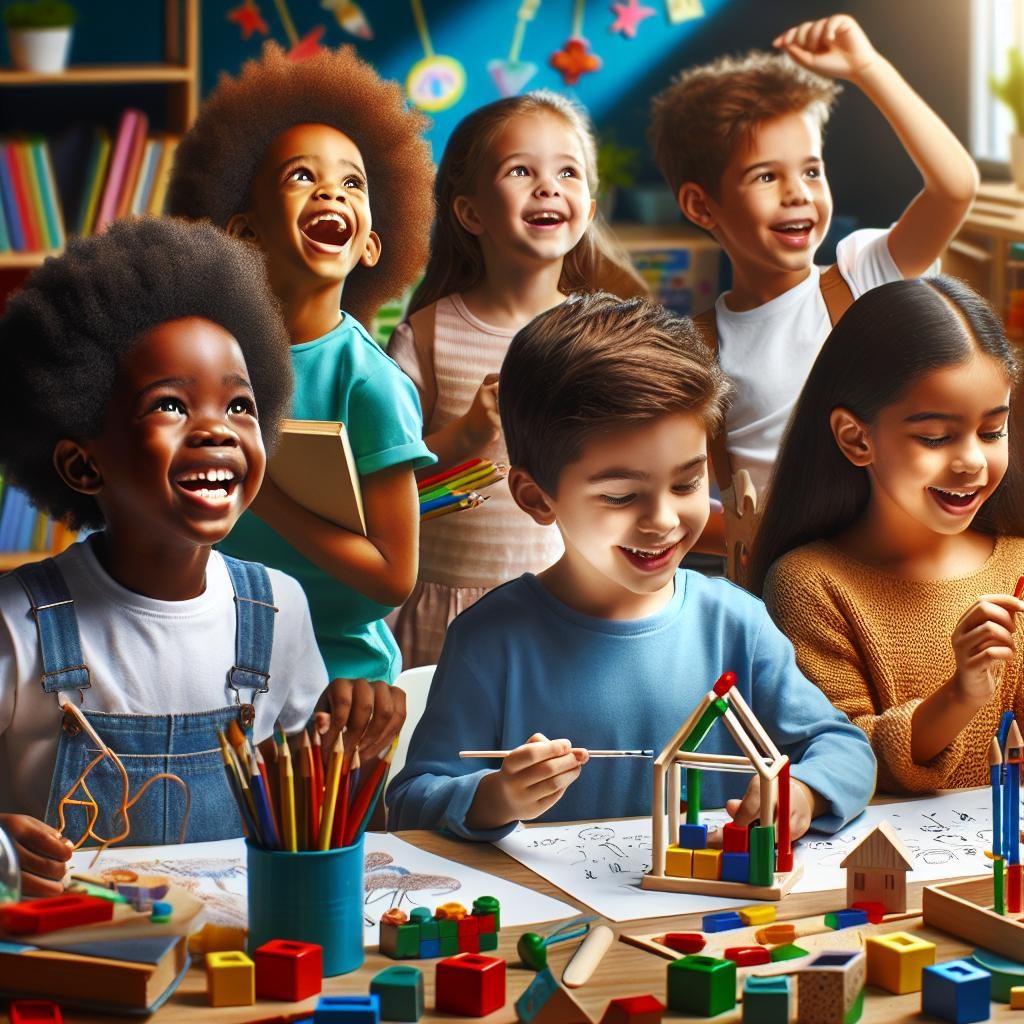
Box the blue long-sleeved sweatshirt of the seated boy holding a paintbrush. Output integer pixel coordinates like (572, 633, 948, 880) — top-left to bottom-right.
(387, 569, 876, 840)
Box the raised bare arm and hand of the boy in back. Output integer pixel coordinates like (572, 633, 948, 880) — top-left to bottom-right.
(774, 14, 978, 278)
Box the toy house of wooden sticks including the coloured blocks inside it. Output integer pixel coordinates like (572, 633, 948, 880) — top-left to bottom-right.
(641, 672, 803, 900)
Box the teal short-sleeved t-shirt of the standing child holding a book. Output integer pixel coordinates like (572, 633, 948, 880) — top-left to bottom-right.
(219, 313, 436, 683)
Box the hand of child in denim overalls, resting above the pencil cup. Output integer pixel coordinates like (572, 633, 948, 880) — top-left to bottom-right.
(316, 679, 406, 761)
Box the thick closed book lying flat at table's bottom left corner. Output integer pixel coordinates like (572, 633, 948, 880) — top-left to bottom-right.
(0, 935, 189, 1015)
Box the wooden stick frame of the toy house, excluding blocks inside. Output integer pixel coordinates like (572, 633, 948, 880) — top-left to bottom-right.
(641, 672, 803, 900)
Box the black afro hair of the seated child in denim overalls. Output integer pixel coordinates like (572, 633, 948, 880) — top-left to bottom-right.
(0, 218, 292, 529)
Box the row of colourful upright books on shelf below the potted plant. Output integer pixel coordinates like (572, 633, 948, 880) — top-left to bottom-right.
(0, 108, 178, 253)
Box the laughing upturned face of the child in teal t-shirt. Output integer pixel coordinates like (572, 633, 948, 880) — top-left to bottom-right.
(238, 124, 380, 295)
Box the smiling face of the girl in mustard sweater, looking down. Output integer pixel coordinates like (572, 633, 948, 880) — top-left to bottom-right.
(834, 353, 1010, 543)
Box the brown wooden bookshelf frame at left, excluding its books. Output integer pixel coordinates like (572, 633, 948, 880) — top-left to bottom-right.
(0, 0, 200, 572)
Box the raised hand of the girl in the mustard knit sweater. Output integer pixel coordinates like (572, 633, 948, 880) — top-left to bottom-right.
(952, 594, 1024, 708)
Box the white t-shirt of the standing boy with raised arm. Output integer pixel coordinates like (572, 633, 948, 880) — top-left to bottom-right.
(715, 228, 903, 496)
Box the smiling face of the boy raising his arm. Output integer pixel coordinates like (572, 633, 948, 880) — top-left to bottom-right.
(696, 113, 833, 290)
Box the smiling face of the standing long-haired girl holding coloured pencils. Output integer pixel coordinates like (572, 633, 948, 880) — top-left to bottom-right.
(455, 112, 596, 261)
